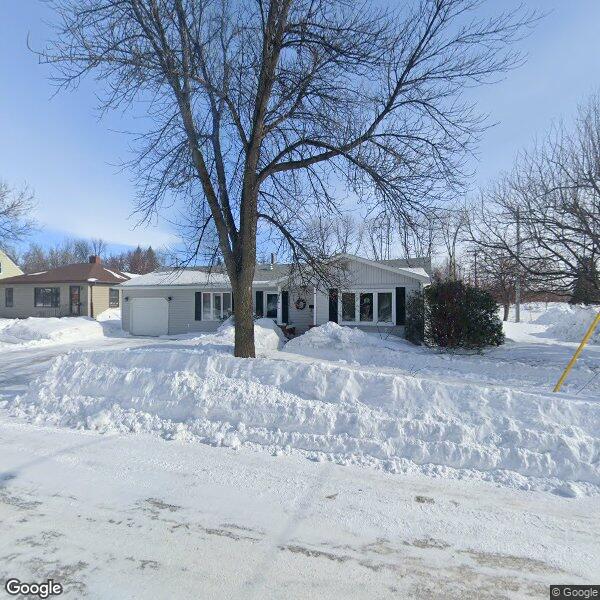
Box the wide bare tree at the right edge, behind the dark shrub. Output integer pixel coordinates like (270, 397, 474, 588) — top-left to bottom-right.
(470, 97, 600, 301)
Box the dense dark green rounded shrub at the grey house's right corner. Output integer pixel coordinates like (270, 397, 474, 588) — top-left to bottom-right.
(425, 281, 504, 349)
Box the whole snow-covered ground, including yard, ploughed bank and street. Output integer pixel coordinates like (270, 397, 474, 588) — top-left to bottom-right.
(0, 305, 600, 598)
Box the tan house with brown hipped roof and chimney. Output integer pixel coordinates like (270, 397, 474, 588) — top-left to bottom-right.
(0, 256, 129, 319)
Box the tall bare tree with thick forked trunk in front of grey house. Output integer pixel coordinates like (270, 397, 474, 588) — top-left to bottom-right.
(41, 0, 532, 357)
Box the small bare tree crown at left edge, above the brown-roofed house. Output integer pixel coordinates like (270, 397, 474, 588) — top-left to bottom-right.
(0, 181, 34, 248)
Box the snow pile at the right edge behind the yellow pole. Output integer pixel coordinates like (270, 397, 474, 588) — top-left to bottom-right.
(535, 302, 600, 344)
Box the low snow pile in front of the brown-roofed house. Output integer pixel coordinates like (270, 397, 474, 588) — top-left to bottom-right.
(0, 317, 104, 349)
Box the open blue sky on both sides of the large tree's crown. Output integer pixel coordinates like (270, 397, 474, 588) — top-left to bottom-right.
(0, 0, 600, 249)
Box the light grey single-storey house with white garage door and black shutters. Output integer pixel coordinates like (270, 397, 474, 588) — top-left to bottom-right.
(118, 254, 431, 335)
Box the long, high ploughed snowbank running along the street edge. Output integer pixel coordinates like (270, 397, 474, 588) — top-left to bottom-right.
(8, 323, 600, 496)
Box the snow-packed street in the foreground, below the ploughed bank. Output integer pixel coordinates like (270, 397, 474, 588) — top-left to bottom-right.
(0, 411, 600, 600)
